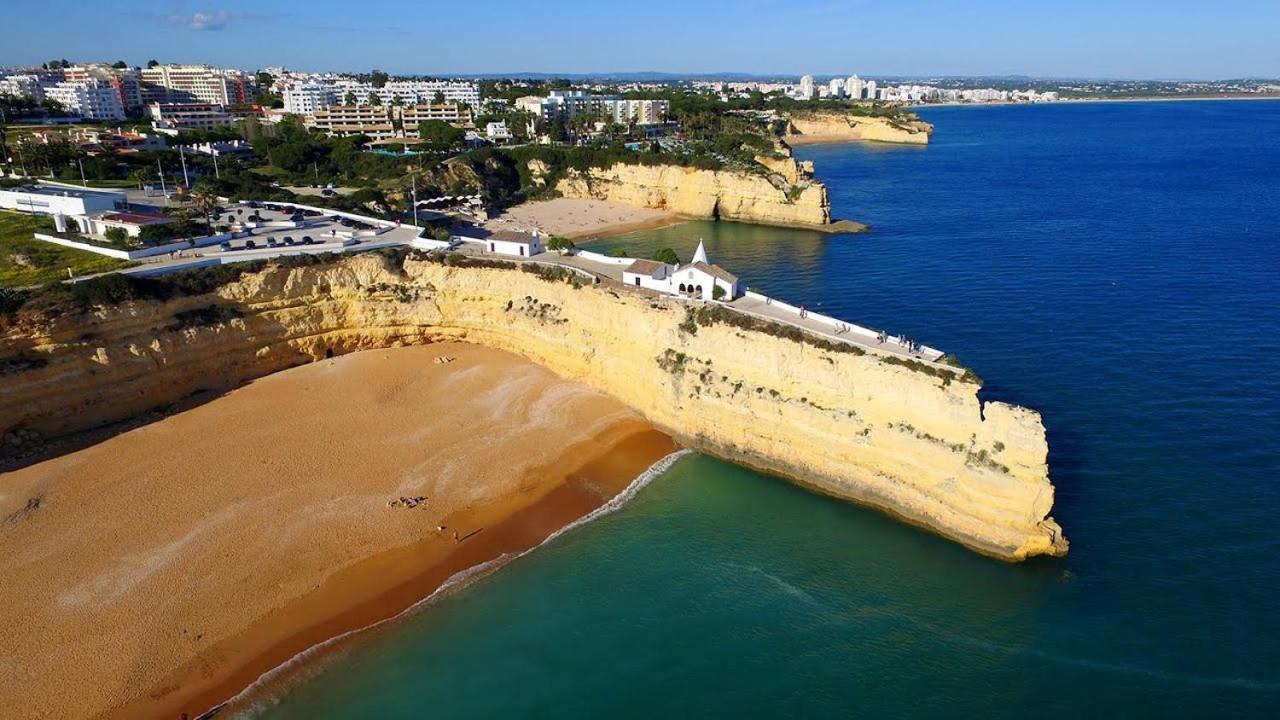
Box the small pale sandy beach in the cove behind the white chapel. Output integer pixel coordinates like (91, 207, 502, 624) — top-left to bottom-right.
(484, 197, 684, 240)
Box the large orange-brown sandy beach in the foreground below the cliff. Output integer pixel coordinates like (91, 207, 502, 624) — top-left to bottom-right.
(0, 343, 675, 717)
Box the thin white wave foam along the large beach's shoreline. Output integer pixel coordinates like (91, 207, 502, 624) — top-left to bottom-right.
(209, 450, 692, 720)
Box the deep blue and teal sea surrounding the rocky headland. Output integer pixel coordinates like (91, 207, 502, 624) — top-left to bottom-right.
(252, 101, 1280, 719)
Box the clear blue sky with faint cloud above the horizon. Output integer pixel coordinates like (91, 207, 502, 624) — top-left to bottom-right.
(0, 0, 1280, 79)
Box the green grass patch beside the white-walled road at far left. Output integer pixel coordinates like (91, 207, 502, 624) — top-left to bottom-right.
(0, 210, 132, 288)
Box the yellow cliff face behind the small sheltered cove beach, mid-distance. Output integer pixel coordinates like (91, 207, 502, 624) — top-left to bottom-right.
(556, 159, 831, 225)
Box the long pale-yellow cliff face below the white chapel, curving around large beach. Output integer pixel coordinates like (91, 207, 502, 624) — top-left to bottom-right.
(0, 255, 1066, 560)
